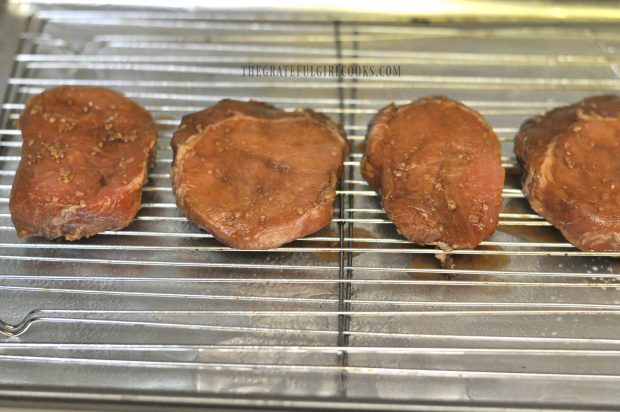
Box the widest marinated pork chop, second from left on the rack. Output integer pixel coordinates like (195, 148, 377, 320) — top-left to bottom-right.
(172, 100, 347, 249)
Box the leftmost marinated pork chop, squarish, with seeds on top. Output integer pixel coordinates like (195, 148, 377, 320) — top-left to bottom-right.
(9, 87, 157, 240)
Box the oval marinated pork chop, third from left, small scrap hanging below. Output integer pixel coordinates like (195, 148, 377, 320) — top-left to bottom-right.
(362, 97, 504, 251)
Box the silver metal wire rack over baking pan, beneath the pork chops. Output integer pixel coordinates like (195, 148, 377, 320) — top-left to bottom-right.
(0, 4, 620, 410)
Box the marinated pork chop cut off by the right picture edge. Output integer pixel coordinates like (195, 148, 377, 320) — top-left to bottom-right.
(515, 96, 620, 251)
